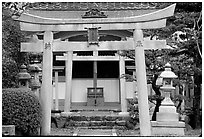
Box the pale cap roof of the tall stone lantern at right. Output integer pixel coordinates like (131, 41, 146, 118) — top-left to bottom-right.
(160, 63, 178, 78)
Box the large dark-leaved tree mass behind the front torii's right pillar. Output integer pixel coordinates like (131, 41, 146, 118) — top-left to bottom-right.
(122, 2, 202, 127)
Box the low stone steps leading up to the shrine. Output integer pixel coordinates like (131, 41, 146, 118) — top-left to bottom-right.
(52, 110, 128, 130)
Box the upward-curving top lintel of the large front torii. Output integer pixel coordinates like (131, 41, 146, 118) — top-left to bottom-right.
(15, 4, 176, 31)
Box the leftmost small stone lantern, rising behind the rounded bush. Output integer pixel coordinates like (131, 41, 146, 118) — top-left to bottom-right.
(18, 64, 31, 88)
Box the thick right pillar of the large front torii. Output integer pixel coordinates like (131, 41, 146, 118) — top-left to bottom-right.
(133, 29, 151, 136)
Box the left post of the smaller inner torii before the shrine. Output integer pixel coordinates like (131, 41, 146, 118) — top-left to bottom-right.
(64, 51, 73, 114)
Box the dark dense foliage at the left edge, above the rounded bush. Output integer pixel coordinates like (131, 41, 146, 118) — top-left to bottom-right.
(2, 3, 27, 88)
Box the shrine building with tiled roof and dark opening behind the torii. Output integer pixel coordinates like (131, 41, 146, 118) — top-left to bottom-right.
(16, 2, 175, 109)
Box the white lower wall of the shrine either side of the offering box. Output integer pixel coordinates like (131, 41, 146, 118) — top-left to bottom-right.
(53, 79, 119, 102)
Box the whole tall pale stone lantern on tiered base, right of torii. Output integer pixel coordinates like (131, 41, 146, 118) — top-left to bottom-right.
(151, 63, 185, 136)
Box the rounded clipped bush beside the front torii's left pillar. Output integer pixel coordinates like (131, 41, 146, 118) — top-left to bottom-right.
(2, 88, 42, 136)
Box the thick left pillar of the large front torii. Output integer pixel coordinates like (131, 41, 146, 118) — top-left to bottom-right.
(40, 31, 53, 136)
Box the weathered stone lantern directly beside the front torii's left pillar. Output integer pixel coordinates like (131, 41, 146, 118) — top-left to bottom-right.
(29, 64, 42, 97)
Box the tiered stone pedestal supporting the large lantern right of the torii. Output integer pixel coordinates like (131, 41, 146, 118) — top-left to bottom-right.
(151, 92, 185, 136)
